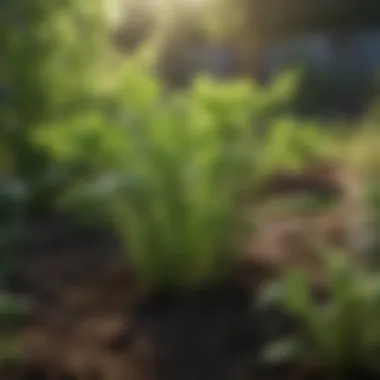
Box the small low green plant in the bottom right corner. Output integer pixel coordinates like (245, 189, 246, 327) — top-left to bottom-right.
(263, 249, 380, 372)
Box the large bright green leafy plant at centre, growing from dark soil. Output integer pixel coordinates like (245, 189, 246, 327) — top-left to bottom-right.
(35, 65, 284, 286)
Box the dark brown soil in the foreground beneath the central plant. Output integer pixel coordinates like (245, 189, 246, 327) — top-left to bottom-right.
(0, 214, 378, 380)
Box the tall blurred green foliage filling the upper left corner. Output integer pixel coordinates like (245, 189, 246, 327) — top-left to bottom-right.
(0, 0, 106, 215)
